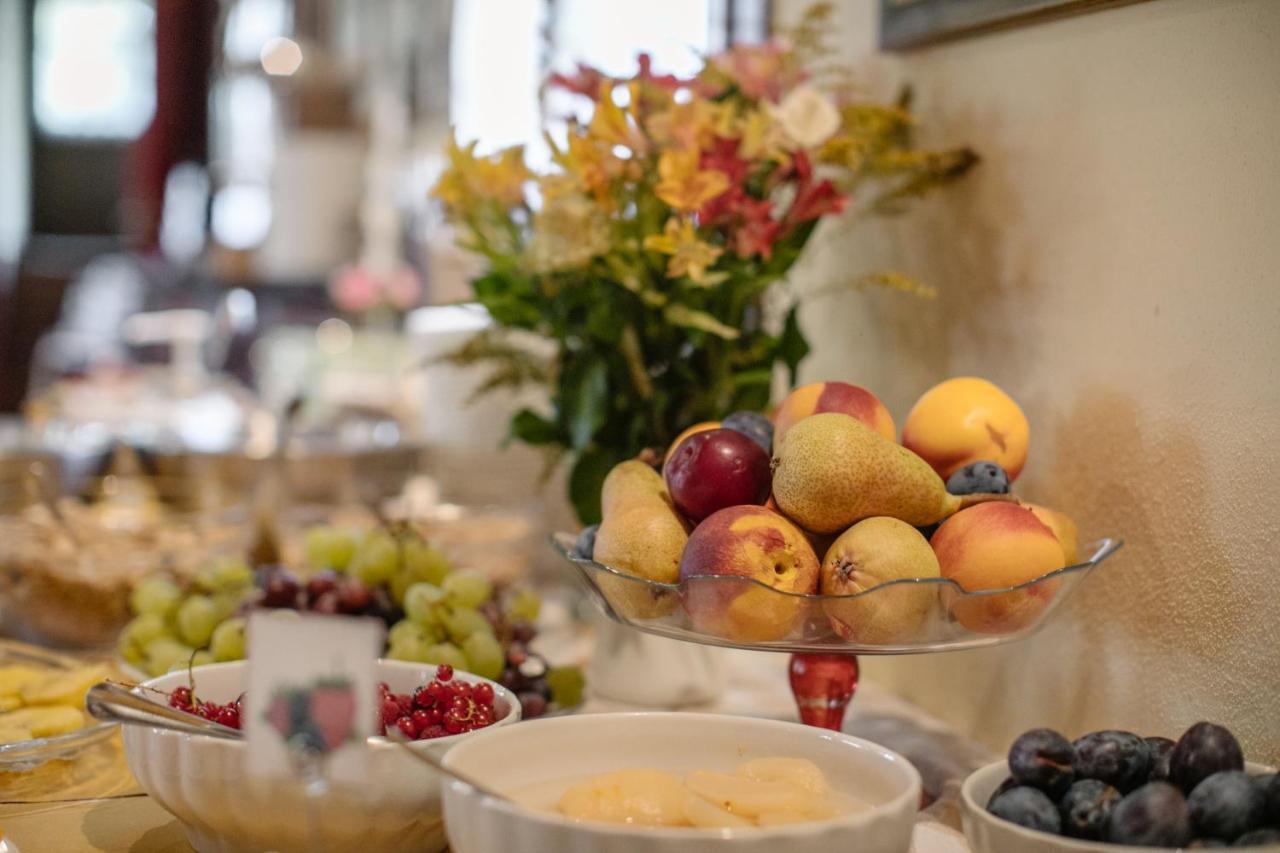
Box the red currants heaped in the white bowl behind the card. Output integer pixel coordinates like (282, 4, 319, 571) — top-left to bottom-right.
(169, 663, 509, 740)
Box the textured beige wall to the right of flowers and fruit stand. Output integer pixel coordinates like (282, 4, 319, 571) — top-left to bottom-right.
(783, 0, 1280, 762)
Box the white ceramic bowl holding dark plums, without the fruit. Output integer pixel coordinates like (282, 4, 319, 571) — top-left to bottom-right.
(960, 761, 1280, 853)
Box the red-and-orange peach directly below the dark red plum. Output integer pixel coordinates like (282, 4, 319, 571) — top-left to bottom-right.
(680, 506, 819, 643)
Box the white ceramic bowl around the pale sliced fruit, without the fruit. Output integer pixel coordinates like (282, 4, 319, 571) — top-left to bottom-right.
(444, 712, 920, 853)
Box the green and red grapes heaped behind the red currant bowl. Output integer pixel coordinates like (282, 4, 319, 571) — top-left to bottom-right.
(118, 525, 582, 717)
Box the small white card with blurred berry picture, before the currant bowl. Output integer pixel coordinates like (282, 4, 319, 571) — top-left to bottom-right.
(243, 610, 385, 776)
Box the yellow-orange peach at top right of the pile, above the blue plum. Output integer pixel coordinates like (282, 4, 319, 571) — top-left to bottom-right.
(902, 377, 1030, 483)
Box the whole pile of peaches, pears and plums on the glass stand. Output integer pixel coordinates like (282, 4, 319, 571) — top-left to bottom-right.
(576, 378, 1078, 644)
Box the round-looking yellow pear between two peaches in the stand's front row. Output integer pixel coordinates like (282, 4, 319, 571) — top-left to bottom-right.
(820, 516, 941, 646)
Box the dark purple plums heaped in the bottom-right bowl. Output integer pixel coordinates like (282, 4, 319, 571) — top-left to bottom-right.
(987, 722, 1280, 848)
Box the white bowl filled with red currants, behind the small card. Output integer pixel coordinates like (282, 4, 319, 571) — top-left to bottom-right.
(124, 660, 520, 853)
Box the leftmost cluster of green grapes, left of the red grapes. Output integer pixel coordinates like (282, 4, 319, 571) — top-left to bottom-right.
(119, 557, 255, 676)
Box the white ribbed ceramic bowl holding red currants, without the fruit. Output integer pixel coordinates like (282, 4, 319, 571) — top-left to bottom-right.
(124, 661, 520, 853)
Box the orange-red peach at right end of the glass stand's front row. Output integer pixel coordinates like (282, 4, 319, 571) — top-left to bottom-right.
(929, 503, 1065, 634)
